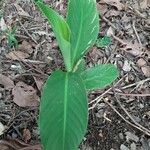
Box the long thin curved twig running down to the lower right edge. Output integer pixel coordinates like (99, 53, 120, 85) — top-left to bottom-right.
(104, 99, 150, 136)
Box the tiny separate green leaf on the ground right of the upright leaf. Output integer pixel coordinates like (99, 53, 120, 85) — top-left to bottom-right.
(96, 36, 111, 48)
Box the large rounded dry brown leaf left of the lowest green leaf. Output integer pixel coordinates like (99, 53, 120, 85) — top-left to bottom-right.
(12, 82, 39, 107)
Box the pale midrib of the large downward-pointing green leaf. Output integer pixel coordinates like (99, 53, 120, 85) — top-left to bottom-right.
(63, 73, 68, 150)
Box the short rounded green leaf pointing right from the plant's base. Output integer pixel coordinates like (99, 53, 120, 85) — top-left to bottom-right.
(81, 64, 118, 90)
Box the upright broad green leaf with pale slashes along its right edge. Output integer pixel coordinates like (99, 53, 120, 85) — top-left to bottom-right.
(67, 0, 99, 67)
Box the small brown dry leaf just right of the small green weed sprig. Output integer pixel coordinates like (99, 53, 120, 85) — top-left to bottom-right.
(19, 40, 34, 54)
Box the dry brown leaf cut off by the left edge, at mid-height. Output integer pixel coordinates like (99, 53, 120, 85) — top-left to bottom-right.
(0, 74, 14, 89)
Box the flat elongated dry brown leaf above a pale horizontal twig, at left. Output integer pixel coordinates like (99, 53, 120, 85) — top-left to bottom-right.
(6, 51, 30, 60)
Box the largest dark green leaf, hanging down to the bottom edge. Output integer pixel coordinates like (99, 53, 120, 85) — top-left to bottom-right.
(39, 71, 88, 150)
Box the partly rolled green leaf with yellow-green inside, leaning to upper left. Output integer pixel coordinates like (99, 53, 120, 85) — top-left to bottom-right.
(36, 0, 72, 71)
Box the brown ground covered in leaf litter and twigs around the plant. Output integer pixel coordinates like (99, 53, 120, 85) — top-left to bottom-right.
(0, 0, 150, 150)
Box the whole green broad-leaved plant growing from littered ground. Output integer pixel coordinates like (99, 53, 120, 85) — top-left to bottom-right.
(35, 0, 118, 150)
